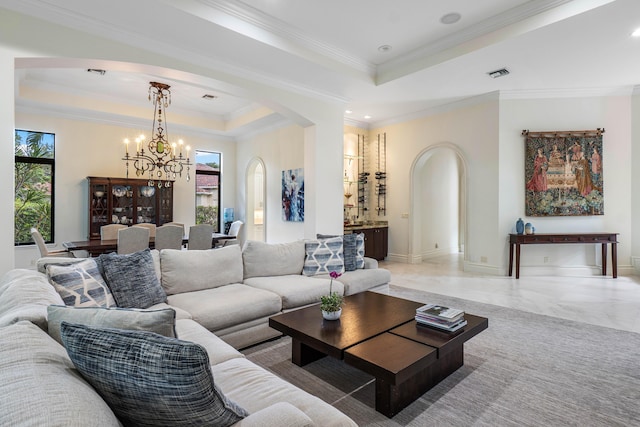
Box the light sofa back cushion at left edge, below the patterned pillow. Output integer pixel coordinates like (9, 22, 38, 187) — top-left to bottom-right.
(0, 269, 64, 332)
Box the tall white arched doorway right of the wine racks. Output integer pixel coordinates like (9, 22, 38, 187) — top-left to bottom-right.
(407, 143, 468, 263)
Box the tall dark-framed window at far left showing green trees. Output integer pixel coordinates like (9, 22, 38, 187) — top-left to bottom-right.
(14, 130, 55, 245)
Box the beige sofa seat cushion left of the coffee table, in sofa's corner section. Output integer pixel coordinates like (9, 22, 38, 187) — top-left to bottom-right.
(169, 286, 282, 332)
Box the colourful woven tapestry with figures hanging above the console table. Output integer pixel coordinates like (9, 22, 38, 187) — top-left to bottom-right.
(522, 128, 604, 216)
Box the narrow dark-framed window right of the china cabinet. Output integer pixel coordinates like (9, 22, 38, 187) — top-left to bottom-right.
(196, 151, 221, 233)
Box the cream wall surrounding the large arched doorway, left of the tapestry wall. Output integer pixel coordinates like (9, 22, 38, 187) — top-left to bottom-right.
(369, 94, 503, 274)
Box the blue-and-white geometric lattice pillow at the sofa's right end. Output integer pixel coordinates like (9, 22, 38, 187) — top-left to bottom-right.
(302, 236, 344, 276)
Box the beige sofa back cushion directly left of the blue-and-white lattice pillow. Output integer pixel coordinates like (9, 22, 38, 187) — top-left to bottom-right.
(242, 240, 305, 279)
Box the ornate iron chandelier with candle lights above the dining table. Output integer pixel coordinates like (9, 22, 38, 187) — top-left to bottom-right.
(122, 82, 191, 188)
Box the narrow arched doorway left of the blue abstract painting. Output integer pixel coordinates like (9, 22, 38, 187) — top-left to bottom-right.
(245, 158, 267, 242)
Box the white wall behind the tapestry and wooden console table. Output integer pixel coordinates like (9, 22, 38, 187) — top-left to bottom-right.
(498, 96, 633, 274)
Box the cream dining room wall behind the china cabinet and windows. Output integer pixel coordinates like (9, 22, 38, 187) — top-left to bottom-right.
(13, 112, 237, 268)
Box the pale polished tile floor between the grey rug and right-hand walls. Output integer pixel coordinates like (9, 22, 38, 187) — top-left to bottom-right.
(380, 254, 640, 332)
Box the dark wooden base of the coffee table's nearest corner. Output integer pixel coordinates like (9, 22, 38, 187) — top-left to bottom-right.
(376, 346, 464, 418)
